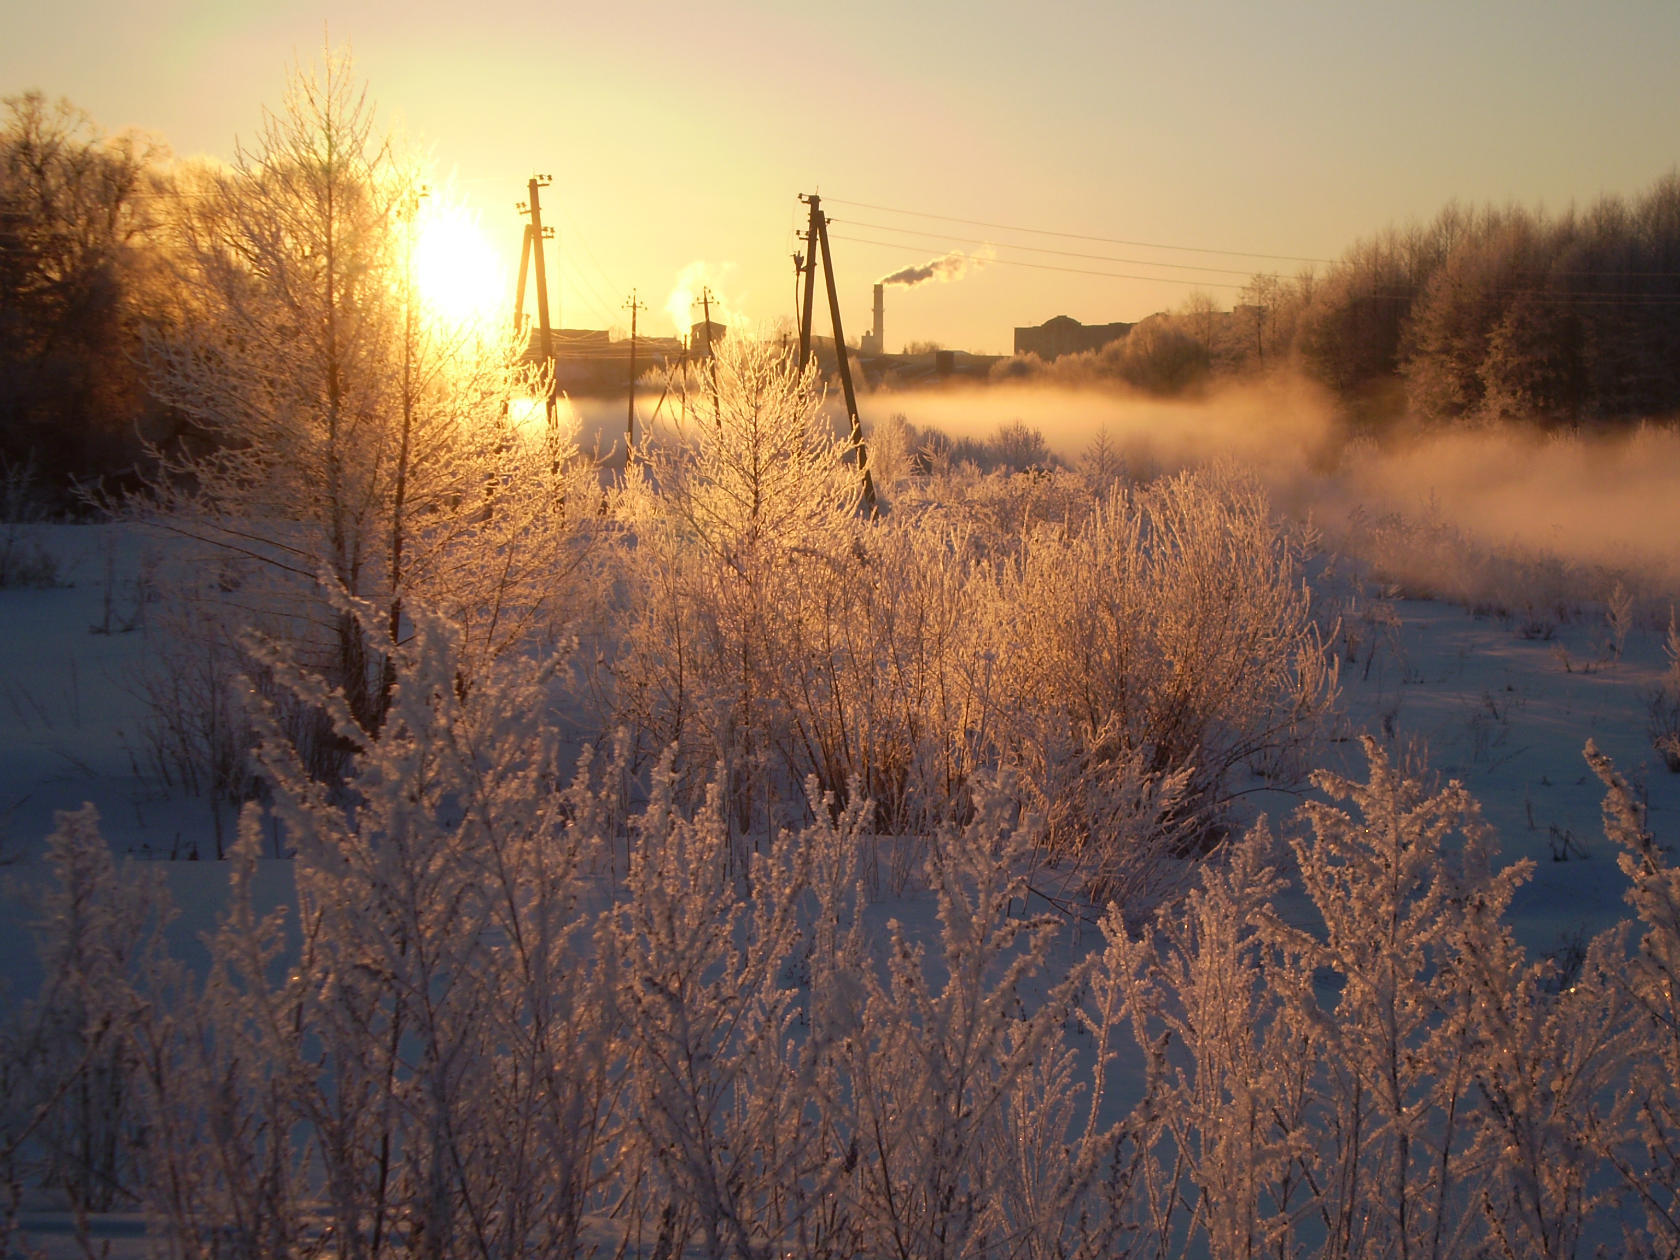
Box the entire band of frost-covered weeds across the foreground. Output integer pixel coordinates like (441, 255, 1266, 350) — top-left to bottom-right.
(16, 672, 1680, 1258)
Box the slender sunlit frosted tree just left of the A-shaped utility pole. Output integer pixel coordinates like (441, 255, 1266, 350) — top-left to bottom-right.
(618, 336, 862, 830)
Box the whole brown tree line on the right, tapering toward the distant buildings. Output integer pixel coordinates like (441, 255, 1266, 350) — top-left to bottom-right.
(995, 173, 1680, 427)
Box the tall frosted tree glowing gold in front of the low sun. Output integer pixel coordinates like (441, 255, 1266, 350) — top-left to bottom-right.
(148, 54, 585, 749)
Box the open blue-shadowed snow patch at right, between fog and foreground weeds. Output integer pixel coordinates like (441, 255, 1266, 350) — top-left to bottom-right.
(1320, 600, 1680, 953)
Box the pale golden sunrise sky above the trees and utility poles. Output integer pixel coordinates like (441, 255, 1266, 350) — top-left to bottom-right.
(0, 0, 1680, 353)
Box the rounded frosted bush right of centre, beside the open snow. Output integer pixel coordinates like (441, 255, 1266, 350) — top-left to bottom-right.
(976, 474, 1336, 892)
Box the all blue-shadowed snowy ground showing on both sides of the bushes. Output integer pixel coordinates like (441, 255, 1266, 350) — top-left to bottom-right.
(0, 514, 1680, 1257)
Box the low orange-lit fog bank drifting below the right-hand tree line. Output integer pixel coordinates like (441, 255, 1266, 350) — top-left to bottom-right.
(862, 381, 1680, 600)
